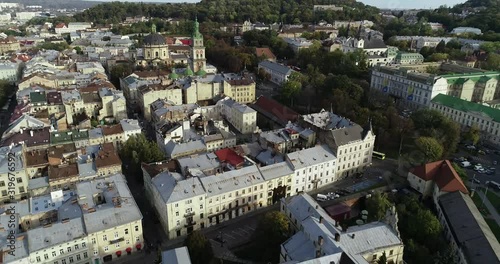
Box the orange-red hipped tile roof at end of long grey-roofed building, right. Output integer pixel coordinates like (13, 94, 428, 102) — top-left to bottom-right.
(411, 160, 469, 194)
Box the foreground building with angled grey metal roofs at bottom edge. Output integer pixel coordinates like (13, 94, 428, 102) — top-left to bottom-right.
(280, 194, 404, 264)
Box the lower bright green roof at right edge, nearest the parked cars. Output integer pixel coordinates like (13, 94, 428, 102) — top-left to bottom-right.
(431, 94, 500, 122)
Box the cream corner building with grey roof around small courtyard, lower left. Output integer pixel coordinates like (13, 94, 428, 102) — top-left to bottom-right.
(76, 174, 144, 263)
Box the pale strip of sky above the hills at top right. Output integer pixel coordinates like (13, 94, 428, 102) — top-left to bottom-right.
(358, 0, 465, 9)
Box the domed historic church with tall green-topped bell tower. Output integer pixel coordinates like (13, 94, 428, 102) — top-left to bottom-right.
(136, 19, 207, 75)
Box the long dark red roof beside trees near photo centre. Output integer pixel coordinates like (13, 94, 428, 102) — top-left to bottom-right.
(252, 96, 299, 124)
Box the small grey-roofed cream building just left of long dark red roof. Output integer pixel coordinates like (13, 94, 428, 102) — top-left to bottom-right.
(217, 97, 257, 134)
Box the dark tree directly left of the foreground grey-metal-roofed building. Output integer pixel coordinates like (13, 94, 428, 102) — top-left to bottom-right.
(254, 211, 290, 263)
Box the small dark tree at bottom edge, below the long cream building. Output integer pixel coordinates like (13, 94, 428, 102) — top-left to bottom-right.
(184, 231, 214, 264)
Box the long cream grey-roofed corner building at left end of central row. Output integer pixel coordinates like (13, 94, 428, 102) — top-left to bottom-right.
(143, 163, 293, 239)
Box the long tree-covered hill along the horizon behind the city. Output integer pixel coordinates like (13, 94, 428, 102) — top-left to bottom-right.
(70, 0, 380, 24)
